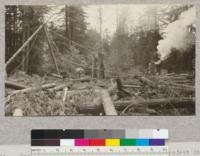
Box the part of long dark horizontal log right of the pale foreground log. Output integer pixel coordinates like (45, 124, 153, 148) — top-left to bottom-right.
(115, 97, 195, 110)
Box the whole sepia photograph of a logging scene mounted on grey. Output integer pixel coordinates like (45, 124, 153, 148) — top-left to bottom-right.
(4, 4, 196, 117)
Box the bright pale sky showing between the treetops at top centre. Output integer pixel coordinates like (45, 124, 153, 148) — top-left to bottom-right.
(83, 4, 145, 35)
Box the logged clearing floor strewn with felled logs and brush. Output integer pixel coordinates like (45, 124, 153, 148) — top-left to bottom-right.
(6, 71, 195, 116)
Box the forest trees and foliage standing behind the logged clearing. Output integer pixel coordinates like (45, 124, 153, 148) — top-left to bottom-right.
(5, 5, 195, 77)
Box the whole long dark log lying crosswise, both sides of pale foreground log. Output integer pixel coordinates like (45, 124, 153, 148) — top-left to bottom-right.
(76, 98, 195, 113)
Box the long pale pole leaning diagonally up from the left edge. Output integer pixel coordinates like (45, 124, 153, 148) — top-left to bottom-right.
(6, 24, 44, 68)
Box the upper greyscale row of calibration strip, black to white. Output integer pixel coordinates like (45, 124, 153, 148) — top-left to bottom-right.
(31, 129, 168, 139)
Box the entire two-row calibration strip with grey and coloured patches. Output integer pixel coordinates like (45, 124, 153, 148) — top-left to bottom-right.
(31, 130, 168, 147)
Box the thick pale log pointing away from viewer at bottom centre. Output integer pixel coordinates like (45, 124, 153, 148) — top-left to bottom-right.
(100, 89, 117, 115)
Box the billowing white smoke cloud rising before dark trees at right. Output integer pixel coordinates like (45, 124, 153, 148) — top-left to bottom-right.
(157, 7, 196, 62)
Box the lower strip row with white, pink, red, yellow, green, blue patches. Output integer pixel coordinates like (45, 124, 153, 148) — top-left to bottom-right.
(31, 139, 165, 147)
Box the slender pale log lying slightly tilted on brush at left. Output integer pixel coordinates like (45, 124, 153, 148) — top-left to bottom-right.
(12, 83, 56, 94)
